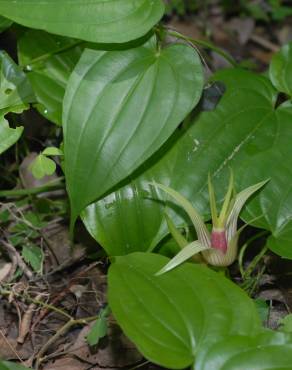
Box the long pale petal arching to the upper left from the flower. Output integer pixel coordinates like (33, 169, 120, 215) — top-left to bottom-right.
(151, 183, 211, 247)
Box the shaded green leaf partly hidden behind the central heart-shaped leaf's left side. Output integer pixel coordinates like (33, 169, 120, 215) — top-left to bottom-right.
(18, 30, 83, 125)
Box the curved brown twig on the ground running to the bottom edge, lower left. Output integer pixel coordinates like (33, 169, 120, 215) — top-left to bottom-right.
(36, 315, 99, 370)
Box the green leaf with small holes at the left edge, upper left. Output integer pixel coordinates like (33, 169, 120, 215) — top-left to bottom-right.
(0, 51, 35, 114)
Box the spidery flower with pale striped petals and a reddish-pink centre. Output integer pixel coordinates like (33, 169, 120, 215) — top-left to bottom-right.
(152, 172, 269, 275)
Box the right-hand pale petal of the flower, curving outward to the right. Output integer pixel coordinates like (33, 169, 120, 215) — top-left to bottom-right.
(226, 179, 270, 243)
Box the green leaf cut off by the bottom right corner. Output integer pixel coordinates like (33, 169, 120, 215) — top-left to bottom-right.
(196, 331, 292, 370)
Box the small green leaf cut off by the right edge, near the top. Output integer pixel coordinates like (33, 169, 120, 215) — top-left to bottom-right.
(269, 43, 292, 96)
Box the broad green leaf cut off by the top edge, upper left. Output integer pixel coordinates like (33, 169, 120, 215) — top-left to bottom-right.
(0, 0, 164, 43)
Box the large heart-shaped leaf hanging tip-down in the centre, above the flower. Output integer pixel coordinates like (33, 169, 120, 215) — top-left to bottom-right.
(63, 42, 203, 228)
